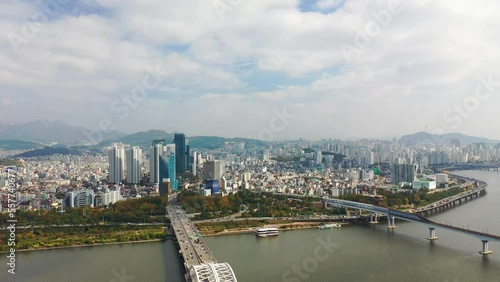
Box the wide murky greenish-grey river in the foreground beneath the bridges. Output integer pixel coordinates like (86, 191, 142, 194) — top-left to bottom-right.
(0, 171, 500, 282)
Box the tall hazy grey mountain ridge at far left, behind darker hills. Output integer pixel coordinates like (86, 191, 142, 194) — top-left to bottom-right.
(0, 120, 126, 145)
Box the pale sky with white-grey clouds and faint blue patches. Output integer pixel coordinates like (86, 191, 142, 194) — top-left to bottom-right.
(0, 0, 500, 139)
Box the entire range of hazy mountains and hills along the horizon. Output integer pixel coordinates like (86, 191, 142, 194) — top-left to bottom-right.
(0, 120, 499, 150)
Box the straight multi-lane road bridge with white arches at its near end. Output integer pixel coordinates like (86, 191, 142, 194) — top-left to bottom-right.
(167, 196, 237, 282)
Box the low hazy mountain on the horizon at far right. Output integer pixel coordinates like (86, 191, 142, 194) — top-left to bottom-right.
(399, 132, 498, 145)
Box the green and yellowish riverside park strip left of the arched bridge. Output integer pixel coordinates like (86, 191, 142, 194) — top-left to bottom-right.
(0, 197, 167, 251)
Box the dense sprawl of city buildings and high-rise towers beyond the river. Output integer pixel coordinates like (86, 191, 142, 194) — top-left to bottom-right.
(0, 134, 500, 210)
